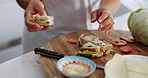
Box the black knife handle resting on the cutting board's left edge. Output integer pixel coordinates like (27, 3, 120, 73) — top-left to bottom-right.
(34, 48, 65, 57)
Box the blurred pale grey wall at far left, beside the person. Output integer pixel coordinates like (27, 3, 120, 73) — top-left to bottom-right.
(0, 0, 24, 49)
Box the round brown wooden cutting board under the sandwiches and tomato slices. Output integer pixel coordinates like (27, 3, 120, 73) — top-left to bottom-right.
(40, 30, 148, 78)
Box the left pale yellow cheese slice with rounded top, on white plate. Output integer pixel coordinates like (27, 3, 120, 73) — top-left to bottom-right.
(105, 54, 128, 78)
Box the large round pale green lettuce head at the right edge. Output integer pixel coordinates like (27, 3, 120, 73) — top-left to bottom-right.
(128, 8, 148, 45)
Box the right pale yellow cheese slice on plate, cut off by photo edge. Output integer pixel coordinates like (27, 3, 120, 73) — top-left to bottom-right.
(126, 59, 148, 78)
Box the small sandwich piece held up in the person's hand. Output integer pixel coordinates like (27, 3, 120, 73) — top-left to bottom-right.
(34, 16, 54, 26)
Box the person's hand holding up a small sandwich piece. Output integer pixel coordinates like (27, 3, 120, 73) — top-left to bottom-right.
(24, 0, 51, 32)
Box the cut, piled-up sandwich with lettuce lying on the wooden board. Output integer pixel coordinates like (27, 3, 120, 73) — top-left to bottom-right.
(77, 34, 113, 58)
